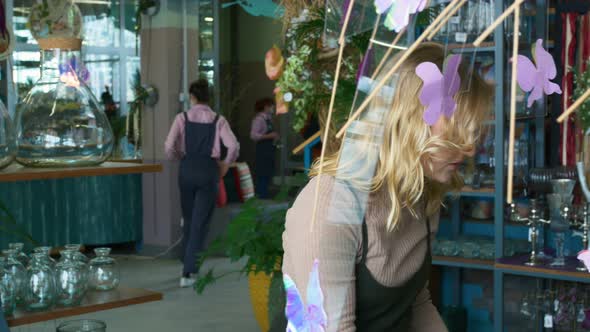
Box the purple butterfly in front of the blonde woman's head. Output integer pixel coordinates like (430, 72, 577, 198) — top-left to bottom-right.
(416, 54, 461, 126)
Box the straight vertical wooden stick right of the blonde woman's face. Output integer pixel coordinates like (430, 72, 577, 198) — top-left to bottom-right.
(506, 6, 520, 204)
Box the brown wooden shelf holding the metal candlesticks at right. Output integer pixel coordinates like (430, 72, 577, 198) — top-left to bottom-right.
(495, 255, 590, 282)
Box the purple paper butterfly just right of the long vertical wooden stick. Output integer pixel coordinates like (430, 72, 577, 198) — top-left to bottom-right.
(516, 39, 561, 107)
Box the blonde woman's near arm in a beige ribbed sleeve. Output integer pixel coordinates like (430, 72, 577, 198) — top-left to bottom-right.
(283, 176, 362, 332)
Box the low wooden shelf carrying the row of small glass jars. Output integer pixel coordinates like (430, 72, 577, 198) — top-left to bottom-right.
(6, 287, 162, 327)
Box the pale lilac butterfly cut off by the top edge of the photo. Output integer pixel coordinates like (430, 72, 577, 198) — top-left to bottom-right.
(375, 0, 427, 32)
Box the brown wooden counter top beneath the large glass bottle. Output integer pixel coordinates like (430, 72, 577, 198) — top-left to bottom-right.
(0, 162, 162, 182)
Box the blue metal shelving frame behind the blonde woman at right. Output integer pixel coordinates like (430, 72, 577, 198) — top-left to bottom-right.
(433, 0, 590, 332)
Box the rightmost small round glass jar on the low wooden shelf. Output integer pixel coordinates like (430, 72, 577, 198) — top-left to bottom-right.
(89, 248, 119, 290)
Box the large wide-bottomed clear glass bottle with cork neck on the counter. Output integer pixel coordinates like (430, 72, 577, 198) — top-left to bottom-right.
(15, 0, 114, 167)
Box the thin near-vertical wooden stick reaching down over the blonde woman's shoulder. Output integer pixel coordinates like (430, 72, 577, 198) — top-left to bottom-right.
(310, 0, 355, 229)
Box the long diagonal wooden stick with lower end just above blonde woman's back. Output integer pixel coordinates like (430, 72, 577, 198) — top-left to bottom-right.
(336, 0, 465, 138)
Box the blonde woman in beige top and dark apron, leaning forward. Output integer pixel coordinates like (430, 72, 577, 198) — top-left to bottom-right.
(282, 43, 493, 332)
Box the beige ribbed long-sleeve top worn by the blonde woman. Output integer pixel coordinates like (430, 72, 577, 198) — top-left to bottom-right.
(282, 176, 447, 332)
